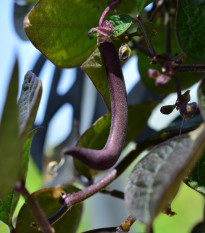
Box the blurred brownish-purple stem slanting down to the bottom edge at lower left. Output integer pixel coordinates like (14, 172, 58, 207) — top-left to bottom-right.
(15, 182, 53, 233)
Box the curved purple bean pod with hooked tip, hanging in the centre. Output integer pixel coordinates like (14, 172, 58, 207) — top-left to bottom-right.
(62, 40, 128, 170)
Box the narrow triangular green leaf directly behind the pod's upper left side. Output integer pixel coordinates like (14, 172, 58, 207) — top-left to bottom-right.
(81, 48, 110, 110)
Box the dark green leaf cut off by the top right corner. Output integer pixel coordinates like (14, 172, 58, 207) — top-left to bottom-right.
(176, 0, 205, 62)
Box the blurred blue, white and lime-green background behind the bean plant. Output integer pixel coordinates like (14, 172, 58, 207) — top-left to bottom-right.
(0, 0, 203, 233)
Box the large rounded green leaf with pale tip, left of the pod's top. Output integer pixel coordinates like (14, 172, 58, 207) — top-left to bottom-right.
(24, 0, 139, 68)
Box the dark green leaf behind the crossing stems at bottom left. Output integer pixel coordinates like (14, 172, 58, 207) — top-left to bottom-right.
(16, 185, 83, 233)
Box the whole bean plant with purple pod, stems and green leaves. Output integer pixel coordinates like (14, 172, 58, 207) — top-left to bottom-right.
(0, 0, 205, 233)
